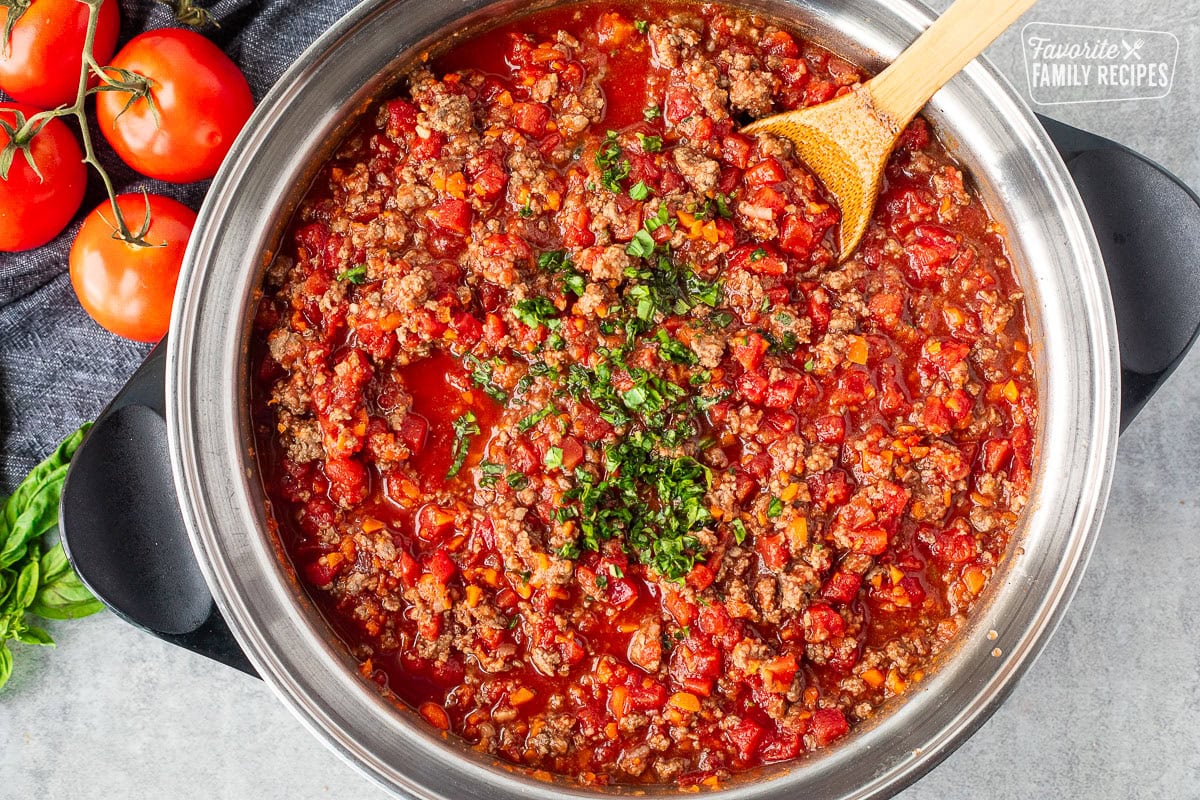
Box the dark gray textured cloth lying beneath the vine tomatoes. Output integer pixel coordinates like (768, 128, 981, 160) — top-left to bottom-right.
(0, 0, 354, 494)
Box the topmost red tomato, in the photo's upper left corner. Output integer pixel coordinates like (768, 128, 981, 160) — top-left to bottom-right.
(0, 0, 121, 108)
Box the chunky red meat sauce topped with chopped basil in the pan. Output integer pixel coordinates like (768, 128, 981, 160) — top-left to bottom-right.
(254, 4, 1037, 787)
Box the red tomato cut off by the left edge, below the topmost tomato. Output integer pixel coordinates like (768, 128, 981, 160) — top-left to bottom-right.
(0, 103, 88, 252)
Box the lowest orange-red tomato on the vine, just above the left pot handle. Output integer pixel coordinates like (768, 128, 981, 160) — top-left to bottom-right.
(70, 194, 196, 342)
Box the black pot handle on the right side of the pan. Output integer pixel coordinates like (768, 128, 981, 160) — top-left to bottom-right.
(1038, 115, 1200, 431)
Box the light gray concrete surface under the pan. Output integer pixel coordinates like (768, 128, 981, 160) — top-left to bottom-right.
(0, 0, 1200, 800)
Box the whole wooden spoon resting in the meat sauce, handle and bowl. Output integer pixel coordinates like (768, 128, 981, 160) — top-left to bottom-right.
(745, 0, 1037, 261)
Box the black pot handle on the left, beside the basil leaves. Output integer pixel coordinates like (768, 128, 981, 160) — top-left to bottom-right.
(59, 339, 256, 675)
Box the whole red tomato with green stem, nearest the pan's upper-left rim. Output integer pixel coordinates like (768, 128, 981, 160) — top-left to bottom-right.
(96, 28, 254, 184)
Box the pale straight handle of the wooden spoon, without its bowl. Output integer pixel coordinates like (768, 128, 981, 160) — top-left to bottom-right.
(868, 0, 1037, 132)
